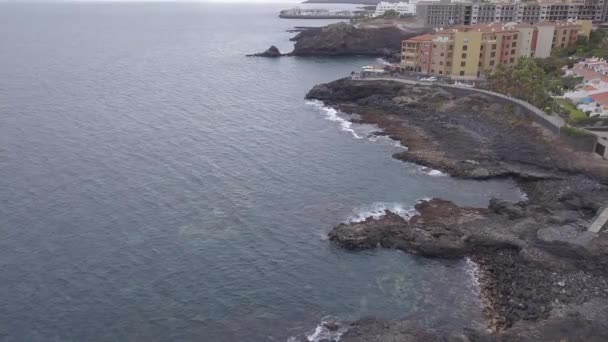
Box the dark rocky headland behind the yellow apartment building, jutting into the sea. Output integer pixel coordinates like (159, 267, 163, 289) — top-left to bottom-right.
(252, 20, 430, 60)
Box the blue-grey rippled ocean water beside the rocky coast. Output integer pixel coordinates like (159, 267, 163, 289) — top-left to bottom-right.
(0, 2, 520, 341)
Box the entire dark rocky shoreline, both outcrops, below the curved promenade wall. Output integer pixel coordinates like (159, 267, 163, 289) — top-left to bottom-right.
(306, 79, 608, 341)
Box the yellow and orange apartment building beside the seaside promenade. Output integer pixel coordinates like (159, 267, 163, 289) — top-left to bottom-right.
(401, 22, 585, 80)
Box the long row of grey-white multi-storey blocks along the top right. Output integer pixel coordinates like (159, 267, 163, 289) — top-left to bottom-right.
(417, 0, 608, 27)
